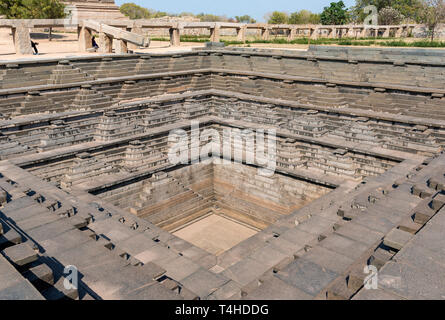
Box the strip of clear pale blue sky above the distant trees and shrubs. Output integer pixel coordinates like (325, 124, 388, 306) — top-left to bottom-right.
(115, 0, 355, 21)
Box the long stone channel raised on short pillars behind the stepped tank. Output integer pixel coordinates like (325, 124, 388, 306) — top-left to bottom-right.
(0, 19, 416, 54)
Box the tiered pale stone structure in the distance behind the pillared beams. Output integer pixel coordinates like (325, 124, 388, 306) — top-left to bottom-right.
(62, 0, 126, 20)
